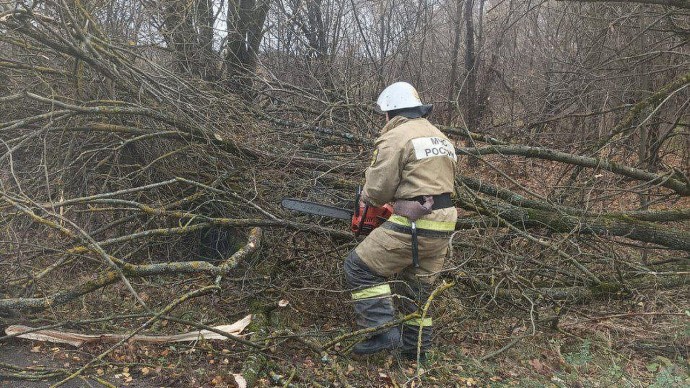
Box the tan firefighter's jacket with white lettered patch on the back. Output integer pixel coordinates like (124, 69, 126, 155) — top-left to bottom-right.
(363, 116, 457, 206)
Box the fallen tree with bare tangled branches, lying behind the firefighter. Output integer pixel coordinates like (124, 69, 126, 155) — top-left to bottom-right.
(0, 0, 690, 310)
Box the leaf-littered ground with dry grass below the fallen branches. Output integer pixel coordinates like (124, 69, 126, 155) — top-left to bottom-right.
(0, 272, 690, 388)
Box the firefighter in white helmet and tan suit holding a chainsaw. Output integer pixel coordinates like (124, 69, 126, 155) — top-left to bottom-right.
(344, 82, 457, 361)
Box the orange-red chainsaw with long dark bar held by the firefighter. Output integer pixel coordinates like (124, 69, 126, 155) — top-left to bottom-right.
(281, 188, 393, 237)
